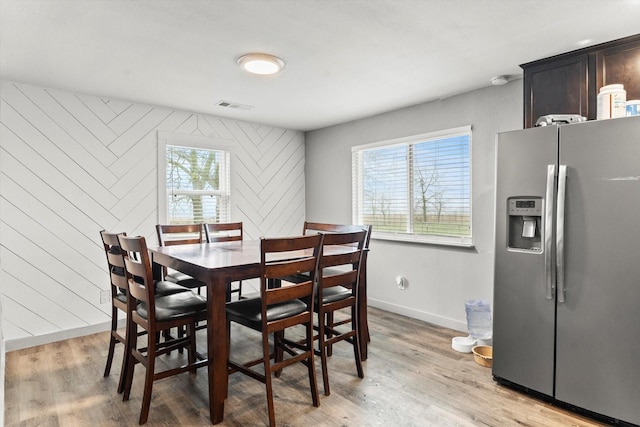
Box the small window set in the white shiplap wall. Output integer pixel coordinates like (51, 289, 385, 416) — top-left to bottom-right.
(158, 134, 231, 224)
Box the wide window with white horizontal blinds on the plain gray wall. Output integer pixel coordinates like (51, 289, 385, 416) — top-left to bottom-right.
(352, 126, 472, 246)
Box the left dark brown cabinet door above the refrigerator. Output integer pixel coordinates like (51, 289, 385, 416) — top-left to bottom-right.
(523, 54, 595, 128)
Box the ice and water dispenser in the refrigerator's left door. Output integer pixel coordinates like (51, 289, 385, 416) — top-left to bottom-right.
(507, 197, 542, 252)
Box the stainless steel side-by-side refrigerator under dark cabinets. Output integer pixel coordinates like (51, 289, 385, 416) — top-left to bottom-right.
(493, 117, 640, 424)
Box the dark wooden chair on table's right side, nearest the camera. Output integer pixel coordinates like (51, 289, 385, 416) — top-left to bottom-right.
(227, 235, 324, 427)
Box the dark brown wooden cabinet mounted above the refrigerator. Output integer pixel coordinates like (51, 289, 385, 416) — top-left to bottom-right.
(521, 34, 640, 128)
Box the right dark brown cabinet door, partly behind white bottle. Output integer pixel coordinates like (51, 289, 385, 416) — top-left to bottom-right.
(595, 40, 640, 101)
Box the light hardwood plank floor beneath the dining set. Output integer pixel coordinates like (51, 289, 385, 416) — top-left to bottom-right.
(5, 309, 601, 426)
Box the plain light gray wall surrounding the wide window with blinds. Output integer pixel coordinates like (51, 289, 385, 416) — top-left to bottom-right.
(305, 80, 523, 331)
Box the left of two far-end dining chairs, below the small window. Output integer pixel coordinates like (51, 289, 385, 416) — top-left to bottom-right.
(156, 224, 205, 293)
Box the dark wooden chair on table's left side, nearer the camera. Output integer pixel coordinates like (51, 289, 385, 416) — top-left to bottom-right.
(118, 235, 207, 424)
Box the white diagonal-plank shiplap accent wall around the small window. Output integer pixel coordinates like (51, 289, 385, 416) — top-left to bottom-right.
(0, 81, 305, 350)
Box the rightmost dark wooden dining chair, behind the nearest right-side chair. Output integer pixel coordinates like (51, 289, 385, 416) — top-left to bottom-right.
(314, 229, 367, 396)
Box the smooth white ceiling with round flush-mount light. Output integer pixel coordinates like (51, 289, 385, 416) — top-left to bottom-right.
(0, 0, 640, 130)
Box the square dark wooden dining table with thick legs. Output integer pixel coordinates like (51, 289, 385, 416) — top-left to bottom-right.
(149, 240, 368, 424)
